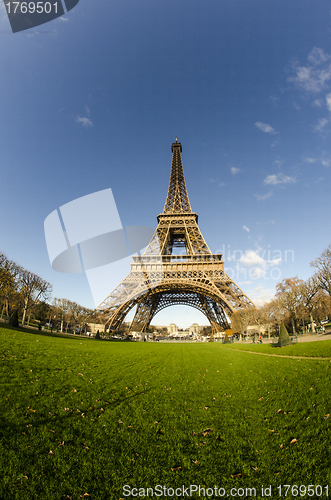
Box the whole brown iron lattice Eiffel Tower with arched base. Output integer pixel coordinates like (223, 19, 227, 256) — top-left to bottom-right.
(97, 138, 254, 333)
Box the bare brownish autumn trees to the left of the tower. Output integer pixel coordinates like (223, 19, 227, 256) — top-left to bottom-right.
(0, 252, 95, 332)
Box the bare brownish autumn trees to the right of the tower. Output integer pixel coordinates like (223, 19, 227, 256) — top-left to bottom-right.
(232, 245, 331, 334)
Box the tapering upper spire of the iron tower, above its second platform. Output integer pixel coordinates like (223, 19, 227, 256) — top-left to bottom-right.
(163, 141, 192, 214)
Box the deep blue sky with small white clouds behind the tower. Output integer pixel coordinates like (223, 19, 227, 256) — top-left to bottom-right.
(0, 0, 331, 327)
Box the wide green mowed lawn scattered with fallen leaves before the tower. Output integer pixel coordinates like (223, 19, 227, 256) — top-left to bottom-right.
(0, 328, 331, 500)
